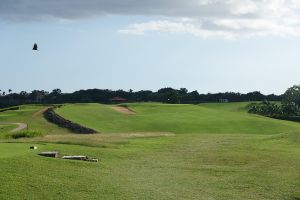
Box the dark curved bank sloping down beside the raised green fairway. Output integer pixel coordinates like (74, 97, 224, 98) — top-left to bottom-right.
(44, 107, 98, 134)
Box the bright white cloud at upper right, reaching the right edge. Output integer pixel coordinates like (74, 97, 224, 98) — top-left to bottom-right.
(119, 0, 300, 39)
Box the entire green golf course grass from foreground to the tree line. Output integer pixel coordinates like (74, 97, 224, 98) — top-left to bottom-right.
(0, 102, 300, 200)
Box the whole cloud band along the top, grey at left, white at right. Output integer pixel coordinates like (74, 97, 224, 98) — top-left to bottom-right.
(0, 0, 300, 38)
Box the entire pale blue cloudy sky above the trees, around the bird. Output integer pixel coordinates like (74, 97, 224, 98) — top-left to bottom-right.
(0, 0, 300, 94)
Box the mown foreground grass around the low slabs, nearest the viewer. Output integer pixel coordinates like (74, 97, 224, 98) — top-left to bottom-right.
(0, 134, 300, 200)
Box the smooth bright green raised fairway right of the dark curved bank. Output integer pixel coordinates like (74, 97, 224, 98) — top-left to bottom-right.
(56, 103, 299, 134)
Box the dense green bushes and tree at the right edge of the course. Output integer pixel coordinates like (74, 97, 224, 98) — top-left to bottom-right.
(249, 86, 300, 121)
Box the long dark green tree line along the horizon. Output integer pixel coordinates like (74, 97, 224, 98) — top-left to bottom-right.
(0, 87, 282, 108)
